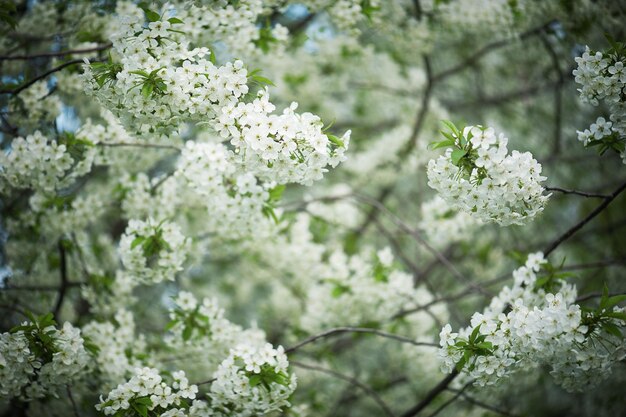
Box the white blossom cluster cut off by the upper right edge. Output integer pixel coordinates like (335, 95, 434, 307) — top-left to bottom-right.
(573, 47, 626, 163)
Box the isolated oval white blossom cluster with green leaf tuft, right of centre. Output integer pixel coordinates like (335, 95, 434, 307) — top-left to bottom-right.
(428, 123, 549, 226)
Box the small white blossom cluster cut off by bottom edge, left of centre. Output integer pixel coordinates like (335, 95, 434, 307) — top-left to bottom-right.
(96, 368, 198, 417)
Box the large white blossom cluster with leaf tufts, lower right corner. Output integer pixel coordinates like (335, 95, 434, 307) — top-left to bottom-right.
(440, 252, 626, 391)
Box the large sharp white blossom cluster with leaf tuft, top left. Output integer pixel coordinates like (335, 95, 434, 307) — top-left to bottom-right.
(84, 12, 248, 135)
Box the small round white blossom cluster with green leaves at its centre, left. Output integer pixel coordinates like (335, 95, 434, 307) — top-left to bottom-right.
(119, 218, 188, 283)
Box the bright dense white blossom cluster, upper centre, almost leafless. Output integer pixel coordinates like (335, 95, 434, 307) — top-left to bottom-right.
(213, 89, 350, 185)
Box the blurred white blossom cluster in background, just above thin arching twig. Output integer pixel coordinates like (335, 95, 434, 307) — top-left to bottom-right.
(301, 248, 423, 332)
